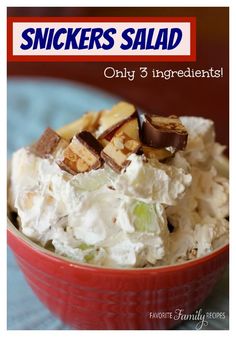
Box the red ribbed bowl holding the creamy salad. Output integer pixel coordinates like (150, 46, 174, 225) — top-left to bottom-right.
(8, 223, 229, 330)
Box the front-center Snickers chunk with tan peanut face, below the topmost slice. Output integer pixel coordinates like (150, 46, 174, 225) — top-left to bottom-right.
(101, 131, 141, 173)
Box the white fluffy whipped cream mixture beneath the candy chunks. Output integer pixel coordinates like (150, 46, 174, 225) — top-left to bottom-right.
(9, 117, 228, 268)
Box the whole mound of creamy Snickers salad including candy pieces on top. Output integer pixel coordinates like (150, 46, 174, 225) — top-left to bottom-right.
(9, 102, 229, 268)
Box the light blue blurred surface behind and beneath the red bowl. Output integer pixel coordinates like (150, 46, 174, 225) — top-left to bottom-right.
(7, 78, 229, 330)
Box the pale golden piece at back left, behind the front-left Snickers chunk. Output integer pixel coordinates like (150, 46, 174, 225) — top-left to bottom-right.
(57, 112, 102, 141)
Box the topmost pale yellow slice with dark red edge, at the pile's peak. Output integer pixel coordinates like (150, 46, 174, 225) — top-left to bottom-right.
(99, 102, 137, 141)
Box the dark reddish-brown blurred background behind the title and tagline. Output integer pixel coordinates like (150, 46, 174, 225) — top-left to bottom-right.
(8, 7, 229, 145)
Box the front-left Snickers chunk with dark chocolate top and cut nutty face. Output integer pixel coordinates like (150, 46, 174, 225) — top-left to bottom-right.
(60, 131, 103, 174)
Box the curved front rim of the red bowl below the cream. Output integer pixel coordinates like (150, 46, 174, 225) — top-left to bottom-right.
(7, 217, 229, 276)
